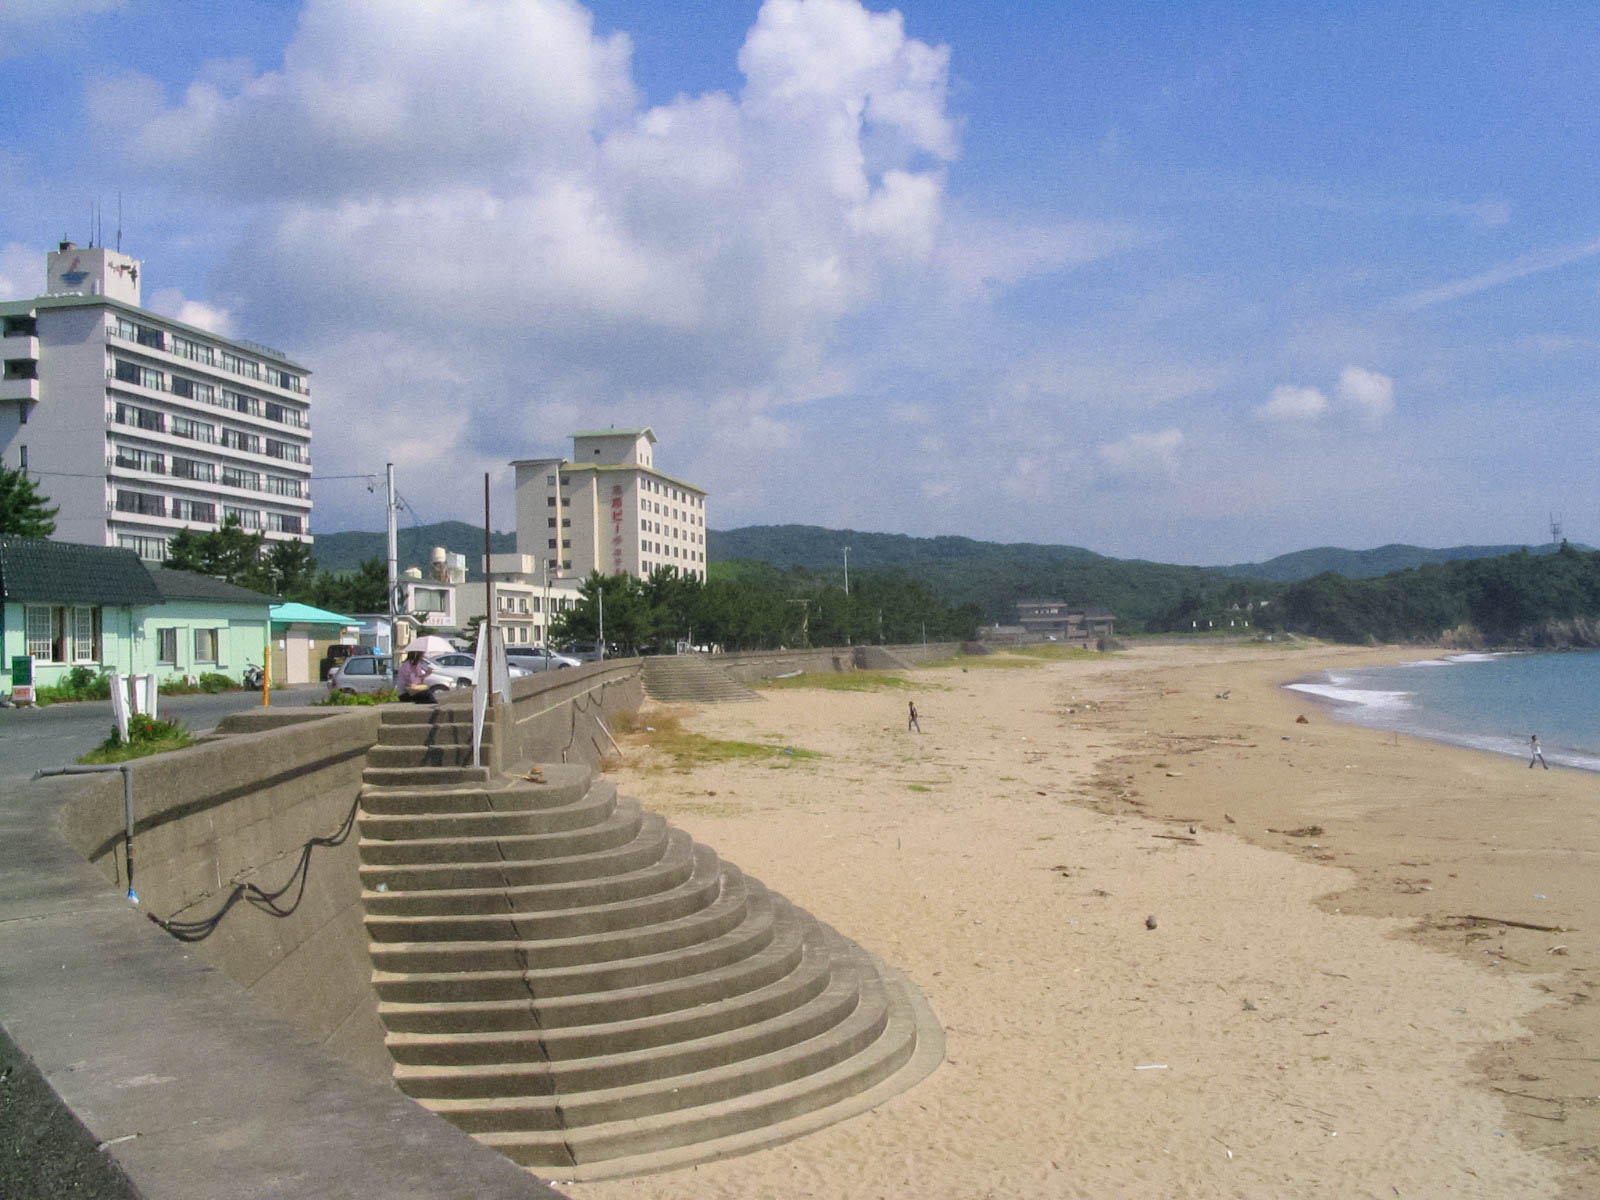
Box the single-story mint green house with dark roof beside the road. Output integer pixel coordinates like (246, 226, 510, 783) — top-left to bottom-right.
(0, 538, 272, 691)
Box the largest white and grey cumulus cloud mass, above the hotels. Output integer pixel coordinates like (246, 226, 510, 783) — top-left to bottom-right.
(91, 0, 1144, 534)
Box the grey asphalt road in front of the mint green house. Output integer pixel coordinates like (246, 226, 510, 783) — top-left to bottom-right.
(0, 683, 328, 789)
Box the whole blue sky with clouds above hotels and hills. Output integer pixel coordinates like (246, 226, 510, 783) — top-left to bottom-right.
(0, 0, 1600, 563)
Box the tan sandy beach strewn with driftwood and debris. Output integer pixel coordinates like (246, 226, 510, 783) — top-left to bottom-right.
(560, 645, 1600, 1200)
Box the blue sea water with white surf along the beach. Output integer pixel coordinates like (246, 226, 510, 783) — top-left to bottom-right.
(1288, 651, 1600, 771)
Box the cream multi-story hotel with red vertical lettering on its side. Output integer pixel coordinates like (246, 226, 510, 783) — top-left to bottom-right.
(512, 429, 706, 581)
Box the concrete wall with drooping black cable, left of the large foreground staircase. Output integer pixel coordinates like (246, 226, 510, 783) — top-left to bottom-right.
(61, 707, 392, 1080)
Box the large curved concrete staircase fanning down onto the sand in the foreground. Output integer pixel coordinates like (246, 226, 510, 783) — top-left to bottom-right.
(360, 706, 944, 1179)
